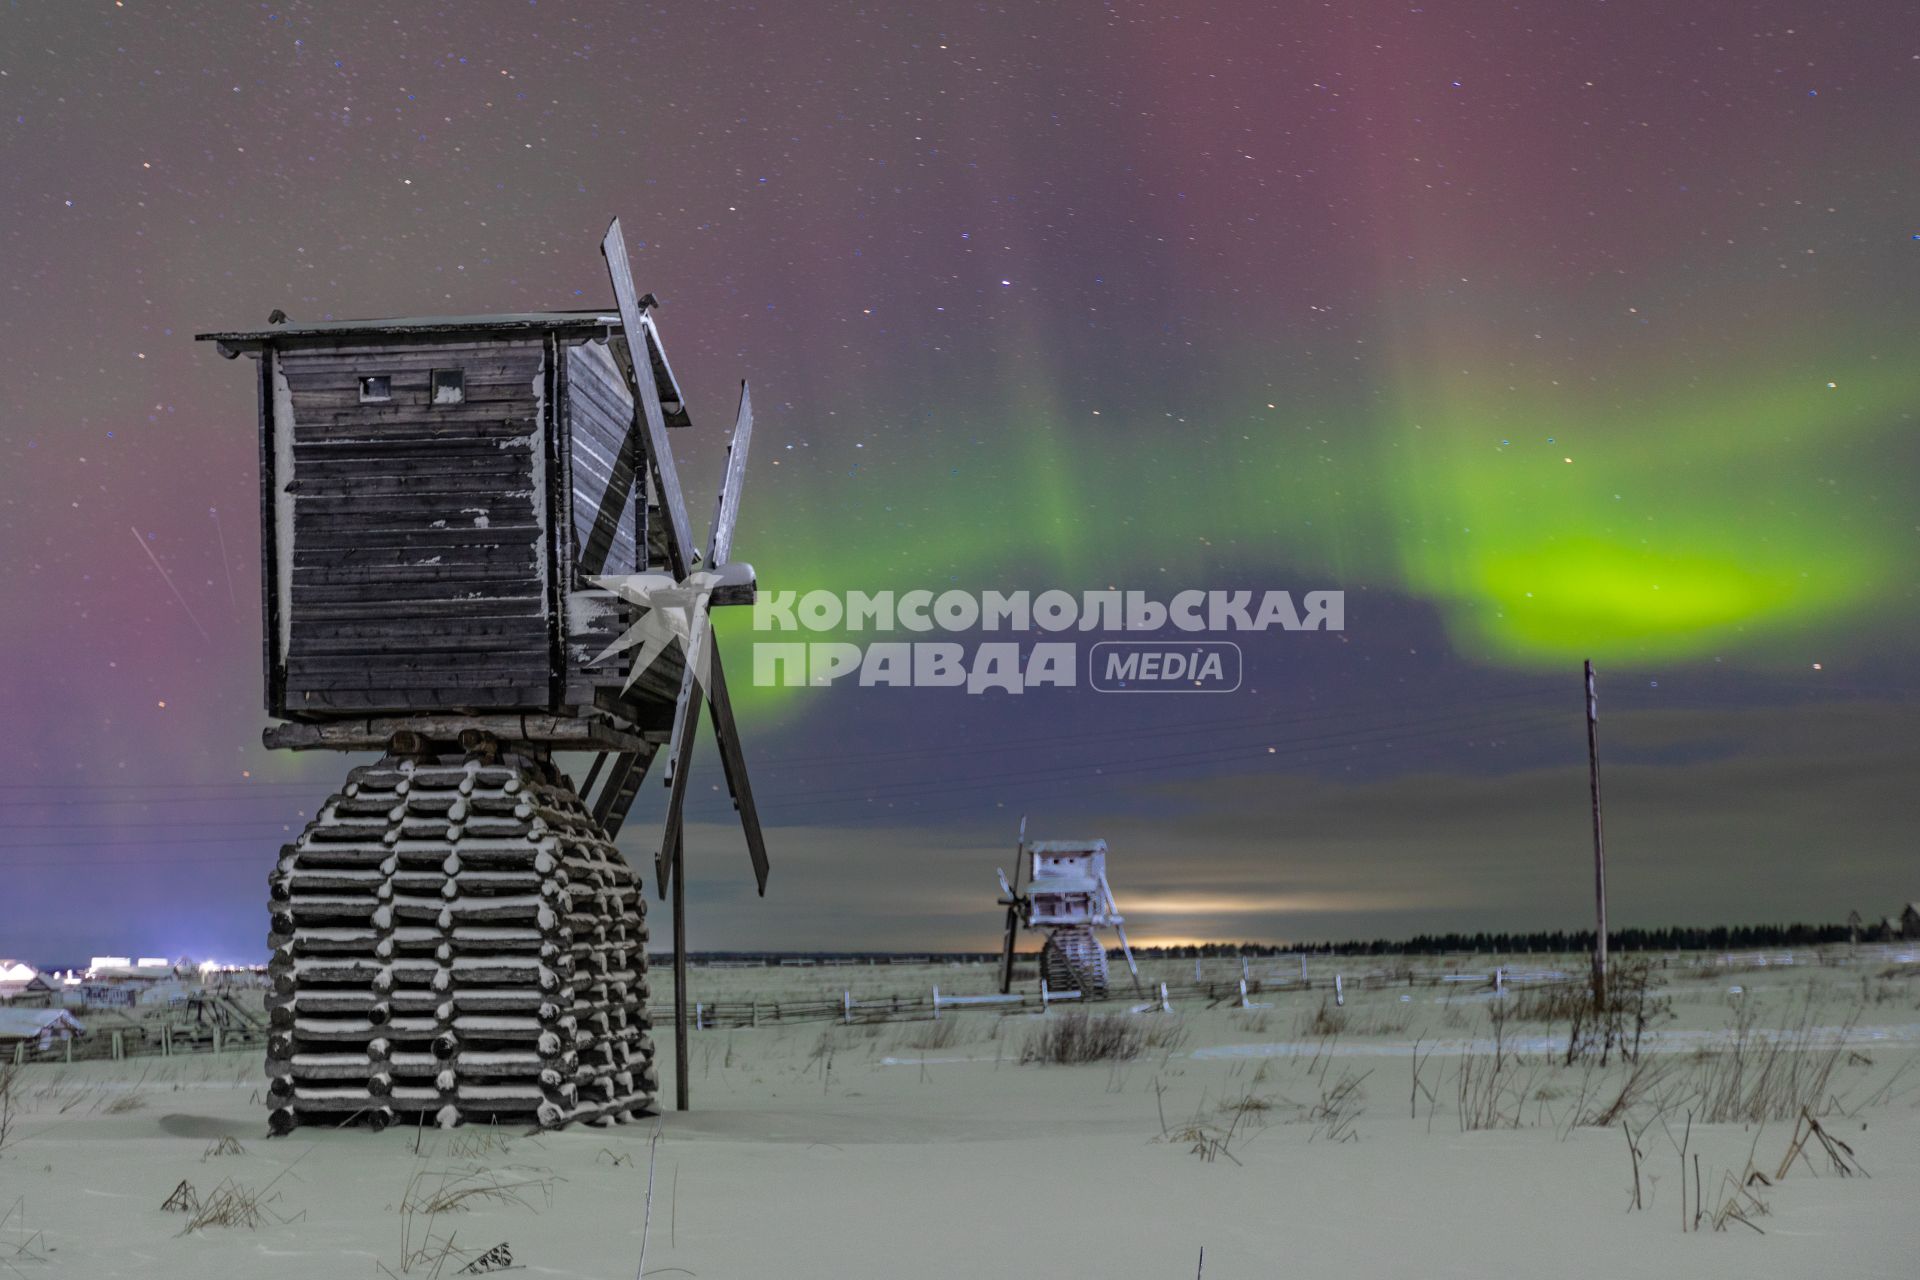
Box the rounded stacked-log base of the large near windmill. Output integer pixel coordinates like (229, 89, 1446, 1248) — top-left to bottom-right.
(267, 754, 659, 1134)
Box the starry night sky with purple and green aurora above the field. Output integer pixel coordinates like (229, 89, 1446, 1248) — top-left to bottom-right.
(0, 0, 1920, 963)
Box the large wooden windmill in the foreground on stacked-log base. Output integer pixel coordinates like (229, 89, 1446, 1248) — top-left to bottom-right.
(202, 221, 768, 1132)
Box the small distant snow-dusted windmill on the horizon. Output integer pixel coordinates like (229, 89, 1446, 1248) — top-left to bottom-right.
(1000, 818, 1140, 998)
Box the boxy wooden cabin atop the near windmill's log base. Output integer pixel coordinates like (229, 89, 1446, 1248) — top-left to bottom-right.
(202, 311, 725, 750)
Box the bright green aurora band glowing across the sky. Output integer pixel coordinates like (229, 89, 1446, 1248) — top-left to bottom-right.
(722, 326, 1920, 695)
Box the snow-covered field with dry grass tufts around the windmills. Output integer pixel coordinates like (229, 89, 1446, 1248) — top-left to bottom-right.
(0, 956, 1920, 1280)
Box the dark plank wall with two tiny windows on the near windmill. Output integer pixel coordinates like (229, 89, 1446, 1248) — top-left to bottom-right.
(276, 336, 551, 716)
